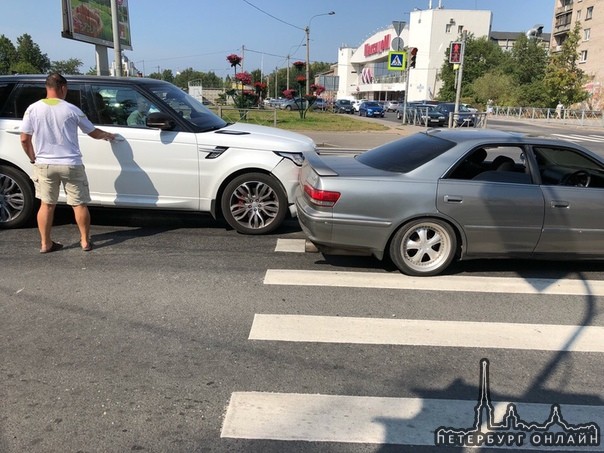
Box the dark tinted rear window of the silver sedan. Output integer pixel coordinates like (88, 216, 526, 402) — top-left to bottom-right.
(356, 133, 455, 173)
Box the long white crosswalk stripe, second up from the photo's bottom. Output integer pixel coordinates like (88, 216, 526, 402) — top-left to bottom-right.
(248, 314, 604, 352)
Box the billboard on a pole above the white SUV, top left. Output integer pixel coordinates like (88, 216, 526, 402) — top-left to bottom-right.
(61, 0, 132, 50)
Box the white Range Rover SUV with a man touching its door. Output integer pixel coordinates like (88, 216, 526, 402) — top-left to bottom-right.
(0, 75, 316, 234)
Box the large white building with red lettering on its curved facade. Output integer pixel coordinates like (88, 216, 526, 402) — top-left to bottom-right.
(337, 2, 492, 101)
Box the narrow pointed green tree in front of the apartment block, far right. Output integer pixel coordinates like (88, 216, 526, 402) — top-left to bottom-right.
(544, 22, 588, 107)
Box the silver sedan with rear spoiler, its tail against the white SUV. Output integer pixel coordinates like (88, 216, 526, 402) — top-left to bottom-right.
(295, 129, 604, 276)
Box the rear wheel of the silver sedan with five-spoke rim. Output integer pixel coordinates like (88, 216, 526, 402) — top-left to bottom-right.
(390, 218, 457, 276)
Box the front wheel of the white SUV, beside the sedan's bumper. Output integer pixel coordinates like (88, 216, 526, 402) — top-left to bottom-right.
(220, 173, 288, 235)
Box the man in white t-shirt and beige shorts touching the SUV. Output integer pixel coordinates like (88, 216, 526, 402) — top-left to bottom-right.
(21, 73, 115, 253)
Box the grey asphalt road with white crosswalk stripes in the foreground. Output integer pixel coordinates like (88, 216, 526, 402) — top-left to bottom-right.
(0, 118, 604, 453)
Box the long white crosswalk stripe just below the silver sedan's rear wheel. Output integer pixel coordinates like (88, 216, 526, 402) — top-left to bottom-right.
(264, 269, 604, 296)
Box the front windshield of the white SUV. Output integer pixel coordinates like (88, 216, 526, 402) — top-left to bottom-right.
(150, 83, 227, 131)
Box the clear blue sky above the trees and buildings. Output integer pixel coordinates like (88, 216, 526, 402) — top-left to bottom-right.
(0, 0, 556, 77)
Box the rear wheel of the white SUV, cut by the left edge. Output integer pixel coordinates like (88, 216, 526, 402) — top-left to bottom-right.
(0, 165, 36, 229)
